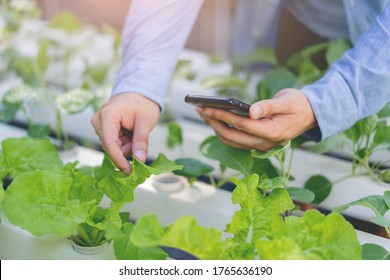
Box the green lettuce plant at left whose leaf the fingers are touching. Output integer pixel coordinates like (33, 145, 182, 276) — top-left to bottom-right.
(0, 137, 181, 256)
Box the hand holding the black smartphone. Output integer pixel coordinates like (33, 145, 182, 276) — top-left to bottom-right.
(196, 89, 317, 151)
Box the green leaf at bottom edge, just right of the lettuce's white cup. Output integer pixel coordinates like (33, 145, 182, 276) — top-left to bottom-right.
(114, 223, 168, 260)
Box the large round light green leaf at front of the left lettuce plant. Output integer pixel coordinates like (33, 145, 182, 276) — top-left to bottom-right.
(2, 171, 93, 237)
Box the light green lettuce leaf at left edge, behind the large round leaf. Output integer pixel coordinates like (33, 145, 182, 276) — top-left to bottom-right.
(1, 137, 63, 178)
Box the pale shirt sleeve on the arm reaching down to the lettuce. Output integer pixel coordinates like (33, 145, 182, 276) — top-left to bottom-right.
(112, 0, 203, 110)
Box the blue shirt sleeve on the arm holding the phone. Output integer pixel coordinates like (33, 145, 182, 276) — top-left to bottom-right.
(301, 4, 390, 140)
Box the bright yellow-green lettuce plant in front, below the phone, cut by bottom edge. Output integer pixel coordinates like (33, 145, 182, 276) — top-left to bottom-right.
(123, 174, 361, 260)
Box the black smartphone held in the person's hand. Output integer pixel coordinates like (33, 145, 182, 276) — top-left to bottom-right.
(184, 94, 251, 116)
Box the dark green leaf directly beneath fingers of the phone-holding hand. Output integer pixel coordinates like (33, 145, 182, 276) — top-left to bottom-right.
(200, 136, 254, 174)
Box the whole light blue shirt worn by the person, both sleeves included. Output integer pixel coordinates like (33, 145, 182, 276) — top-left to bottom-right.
(113, 0, 390, 140)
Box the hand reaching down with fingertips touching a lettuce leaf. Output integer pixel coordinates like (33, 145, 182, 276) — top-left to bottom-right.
(91, 93, 160, 174)
